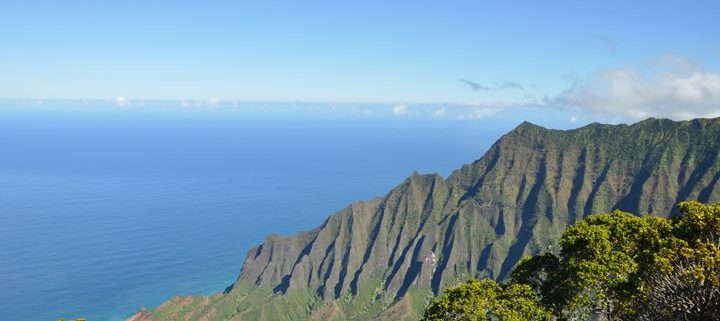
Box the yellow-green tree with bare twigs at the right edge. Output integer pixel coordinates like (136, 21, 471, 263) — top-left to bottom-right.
(638, 201, 720, 321)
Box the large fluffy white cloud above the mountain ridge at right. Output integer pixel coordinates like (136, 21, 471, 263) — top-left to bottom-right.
(554, 55, 720, 120)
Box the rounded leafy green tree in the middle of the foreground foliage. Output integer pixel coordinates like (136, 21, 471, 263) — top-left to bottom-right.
(554, 211, 673, 320)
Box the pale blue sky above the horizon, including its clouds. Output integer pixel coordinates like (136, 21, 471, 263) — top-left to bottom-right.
(0, 0, 720, 120)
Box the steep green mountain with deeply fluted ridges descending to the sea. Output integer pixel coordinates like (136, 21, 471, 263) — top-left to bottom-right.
(131, 118, 720, 321)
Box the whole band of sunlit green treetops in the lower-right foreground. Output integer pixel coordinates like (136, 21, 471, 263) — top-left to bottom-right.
(424, 201, 720, 321)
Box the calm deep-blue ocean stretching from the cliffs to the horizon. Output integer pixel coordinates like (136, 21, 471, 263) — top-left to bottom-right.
(0, 107, 516, 321)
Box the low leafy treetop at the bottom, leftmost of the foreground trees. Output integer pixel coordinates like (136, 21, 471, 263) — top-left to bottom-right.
(423, 279, 551, 321)
